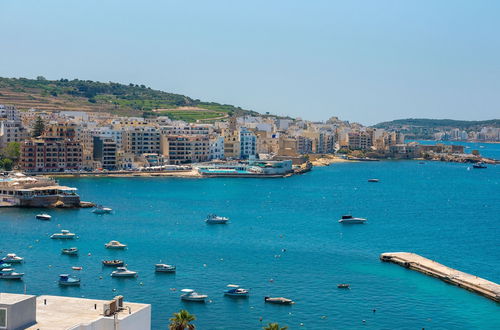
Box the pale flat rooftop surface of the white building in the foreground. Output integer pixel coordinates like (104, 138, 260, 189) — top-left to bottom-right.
(27, 295, 151, 330)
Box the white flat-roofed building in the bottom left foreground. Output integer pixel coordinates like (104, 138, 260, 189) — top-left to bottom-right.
(0, 293, 151, 330)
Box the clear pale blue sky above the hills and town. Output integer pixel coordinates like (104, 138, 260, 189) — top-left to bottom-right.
(0, 0, 500, 124)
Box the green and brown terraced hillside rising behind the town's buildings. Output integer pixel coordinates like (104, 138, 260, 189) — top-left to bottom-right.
(0, 77, 257, 121)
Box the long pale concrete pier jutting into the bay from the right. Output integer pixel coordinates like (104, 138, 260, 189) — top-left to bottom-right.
(380, 252, 500, 302)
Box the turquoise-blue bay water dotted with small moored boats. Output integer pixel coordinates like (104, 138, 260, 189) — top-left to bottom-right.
(0, 161, 500, 329)
